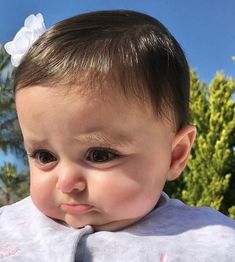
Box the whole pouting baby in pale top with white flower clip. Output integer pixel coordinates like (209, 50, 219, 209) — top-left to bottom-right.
(0, 10, 235, 262)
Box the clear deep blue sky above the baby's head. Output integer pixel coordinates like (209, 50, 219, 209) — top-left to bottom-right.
(0, 0, 235, 168)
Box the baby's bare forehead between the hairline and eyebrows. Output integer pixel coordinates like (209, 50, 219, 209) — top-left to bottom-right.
(16, 83, 176, 141)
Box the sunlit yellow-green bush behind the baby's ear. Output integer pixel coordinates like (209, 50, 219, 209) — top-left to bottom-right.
(166, 69, 235, 217)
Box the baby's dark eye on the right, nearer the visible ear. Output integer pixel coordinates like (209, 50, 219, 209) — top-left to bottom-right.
(87, 148, 120, 163)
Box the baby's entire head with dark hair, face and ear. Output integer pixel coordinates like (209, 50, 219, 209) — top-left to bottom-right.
(15, 11, 195, 230)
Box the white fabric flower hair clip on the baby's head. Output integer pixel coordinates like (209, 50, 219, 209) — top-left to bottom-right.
(4, 13, 46, 67)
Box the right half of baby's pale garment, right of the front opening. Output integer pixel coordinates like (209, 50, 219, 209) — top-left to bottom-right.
(81, 195, 235, 262)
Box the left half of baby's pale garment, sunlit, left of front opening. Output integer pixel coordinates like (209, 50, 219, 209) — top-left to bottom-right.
(0, 197, 85, 262)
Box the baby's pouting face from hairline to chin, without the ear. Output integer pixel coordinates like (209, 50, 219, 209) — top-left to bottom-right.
(16, 86, 174, 230)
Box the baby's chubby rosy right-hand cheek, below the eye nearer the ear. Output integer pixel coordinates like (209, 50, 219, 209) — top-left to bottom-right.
(92, 167, 162, 219)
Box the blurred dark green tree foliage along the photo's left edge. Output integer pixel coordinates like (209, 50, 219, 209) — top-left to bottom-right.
(0, 46, 28, 205)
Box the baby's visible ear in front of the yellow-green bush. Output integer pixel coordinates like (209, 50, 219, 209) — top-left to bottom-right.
(167, 125, 196, 180)
